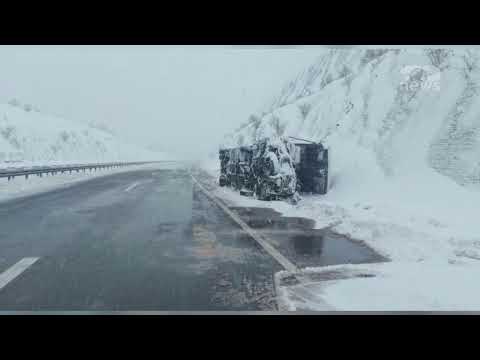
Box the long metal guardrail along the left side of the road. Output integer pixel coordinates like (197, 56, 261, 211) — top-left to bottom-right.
(0, 161, 171, 181)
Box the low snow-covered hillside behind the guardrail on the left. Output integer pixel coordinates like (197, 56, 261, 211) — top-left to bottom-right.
(0, 104, 165, 166)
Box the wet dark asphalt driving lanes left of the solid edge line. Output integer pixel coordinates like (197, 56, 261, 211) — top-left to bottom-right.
(0, 168, 281, 311)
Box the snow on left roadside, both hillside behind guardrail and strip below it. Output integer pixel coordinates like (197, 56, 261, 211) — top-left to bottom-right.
(0, 104, 167, 201)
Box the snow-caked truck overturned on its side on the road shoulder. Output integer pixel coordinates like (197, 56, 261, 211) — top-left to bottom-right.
(219, 138, 328, 201)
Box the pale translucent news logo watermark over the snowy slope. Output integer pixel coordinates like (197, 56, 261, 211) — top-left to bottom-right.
(400, 65, 441, 92)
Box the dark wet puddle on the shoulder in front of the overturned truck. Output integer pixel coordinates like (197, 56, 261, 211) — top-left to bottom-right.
(231, 207, 388, 267)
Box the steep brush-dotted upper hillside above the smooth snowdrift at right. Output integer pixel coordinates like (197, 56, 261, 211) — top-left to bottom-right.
(227, 49, 480, 193)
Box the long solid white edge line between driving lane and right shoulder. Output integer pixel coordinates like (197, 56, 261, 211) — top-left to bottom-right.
(190, 174, 299, 273)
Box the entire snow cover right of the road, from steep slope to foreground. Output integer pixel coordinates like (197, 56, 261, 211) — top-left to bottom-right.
(212, 49, 480, 310)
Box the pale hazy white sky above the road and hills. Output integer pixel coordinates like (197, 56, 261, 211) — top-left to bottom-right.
(0, 46, 322, 158)
